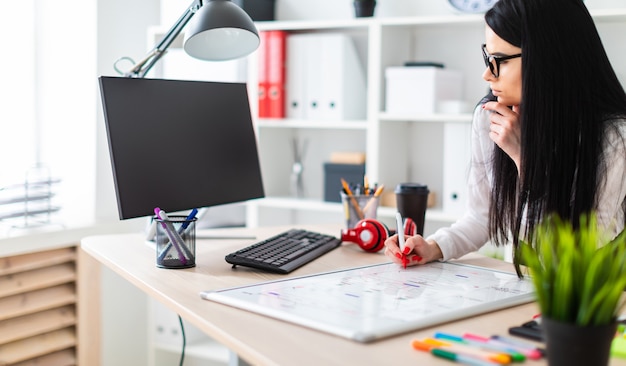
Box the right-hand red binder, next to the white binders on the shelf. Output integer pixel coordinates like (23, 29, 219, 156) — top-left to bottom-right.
(266, 30, 287, 118)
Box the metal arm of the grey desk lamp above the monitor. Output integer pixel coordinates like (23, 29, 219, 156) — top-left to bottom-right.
(124, 0, 203, 78)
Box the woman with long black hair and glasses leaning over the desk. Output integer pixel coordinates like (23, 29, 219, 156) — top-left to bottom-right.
(385, 0, 626, 274)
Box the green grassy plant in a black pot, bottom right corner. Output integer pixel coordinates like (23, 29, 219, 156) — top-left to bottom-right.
(516, 214, 626, 365)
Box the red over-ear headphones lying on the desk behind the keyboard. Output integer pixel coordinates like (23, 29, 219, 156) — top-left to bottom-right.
(341, 218, 417, 253)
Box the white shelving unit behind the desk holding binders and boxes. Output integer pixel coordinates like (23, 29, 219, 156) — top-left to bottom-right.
(148, 6, 626, 365)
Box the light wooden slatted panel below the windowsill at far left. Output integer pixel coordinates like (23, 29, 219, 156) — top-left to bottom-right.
(0, 245, 78, 366)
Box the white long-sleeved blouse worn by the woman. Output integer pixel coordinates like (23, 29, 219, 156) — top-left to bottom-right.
(427, 106, 626, 261)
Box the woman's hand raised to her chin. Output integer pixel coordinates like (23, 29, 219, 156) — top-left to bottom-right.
(483, 102, 522, 172)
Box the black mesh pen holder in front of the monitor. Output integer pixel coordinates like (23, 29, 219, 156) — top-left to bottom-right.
(154, 215, 196, 268)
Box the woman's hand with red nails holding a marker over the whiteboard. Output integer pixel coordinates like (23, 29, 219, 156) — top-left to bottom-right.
(385, 235, 443, 267)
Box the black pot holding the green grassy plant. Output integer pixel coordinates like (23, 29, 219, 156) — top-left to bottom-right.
(541, 317, 617, 366)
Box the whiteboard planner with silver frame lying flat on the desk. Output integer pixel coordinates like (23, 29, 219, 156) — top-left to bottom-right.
(200, 262, 534, 342)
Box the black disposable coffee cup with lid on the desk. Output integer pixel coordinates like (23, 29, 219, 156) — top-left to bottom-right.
(395, 183, 430, 235)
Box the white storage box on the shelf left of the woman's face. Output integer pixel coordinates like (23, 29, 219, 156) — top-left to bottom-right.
(385, 66, 463, 115)
